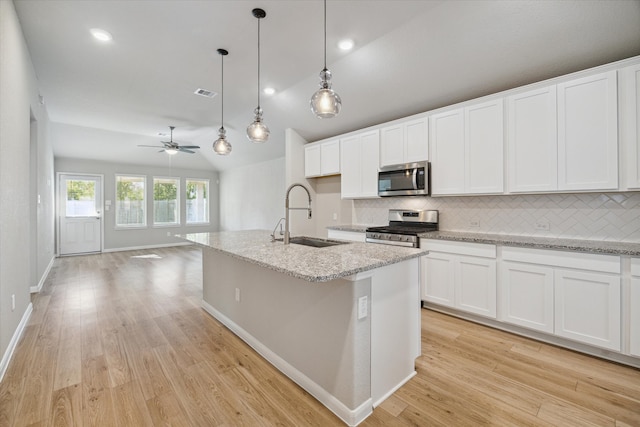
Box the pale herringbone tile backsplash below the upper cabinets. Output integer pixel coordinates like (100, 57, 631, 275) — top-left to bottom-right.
(353, 192, 640, 243)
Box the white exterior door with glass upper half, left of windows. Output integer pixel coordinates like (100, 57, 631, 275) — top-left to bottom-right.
(58, 174, 102, 255)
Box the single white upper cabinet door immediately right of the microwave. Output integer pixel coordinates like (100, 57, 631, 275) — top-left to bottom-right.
(429, 109, 465, 195)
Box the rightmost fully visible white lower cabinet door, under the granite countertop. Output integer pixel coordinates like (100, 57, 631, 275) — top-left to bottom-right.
(554, 270, 621, 351)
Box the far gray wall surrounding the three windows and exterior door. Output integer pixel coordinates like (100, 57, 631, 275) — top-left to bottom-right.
(55, 158, 220, 251)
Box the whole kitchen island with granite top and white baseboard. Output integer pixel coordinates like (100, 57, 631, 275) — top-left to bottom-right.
(180, 230, 426, 425)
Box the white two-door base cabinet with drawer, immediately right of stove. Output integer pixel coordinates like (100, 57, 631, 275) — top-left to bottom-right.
(421, 240, 497, 319)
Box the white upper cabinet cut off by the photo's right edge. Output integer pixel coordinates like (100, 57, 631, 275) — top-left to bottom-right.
(619, 64, 640, 190)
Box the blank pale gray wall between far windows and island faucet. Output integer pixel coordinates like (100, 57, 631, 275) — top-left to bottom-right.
(220, 157, 285, 230)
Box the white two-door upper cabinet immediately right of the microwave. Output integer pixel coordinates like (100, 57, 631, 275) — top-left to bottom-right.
(430, 98, 504, 195)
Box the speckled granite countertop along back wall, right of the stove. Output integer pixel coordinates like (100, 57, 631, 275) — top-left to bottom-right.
(419, 231, 640, 256)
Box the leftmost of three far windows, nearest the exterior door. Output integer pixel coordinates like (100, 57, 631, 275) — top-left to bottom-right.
(116, 175, 147, 227)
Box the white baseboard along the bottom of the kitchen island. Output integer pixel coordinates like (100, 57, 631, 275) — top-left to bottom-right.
(202, 300, 373, 426)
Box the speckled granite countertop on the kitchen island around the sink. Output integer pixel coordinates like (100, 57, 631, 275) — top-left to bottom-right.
(176, 230, 427, 282)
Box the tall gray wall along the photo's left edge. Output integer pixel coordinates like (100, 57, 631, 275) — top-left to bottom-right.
(0, 1, 54, 368)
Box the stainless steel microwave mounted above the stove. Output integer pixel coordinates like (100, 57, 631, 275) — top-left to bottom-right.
(378, 162, 429, 197)
